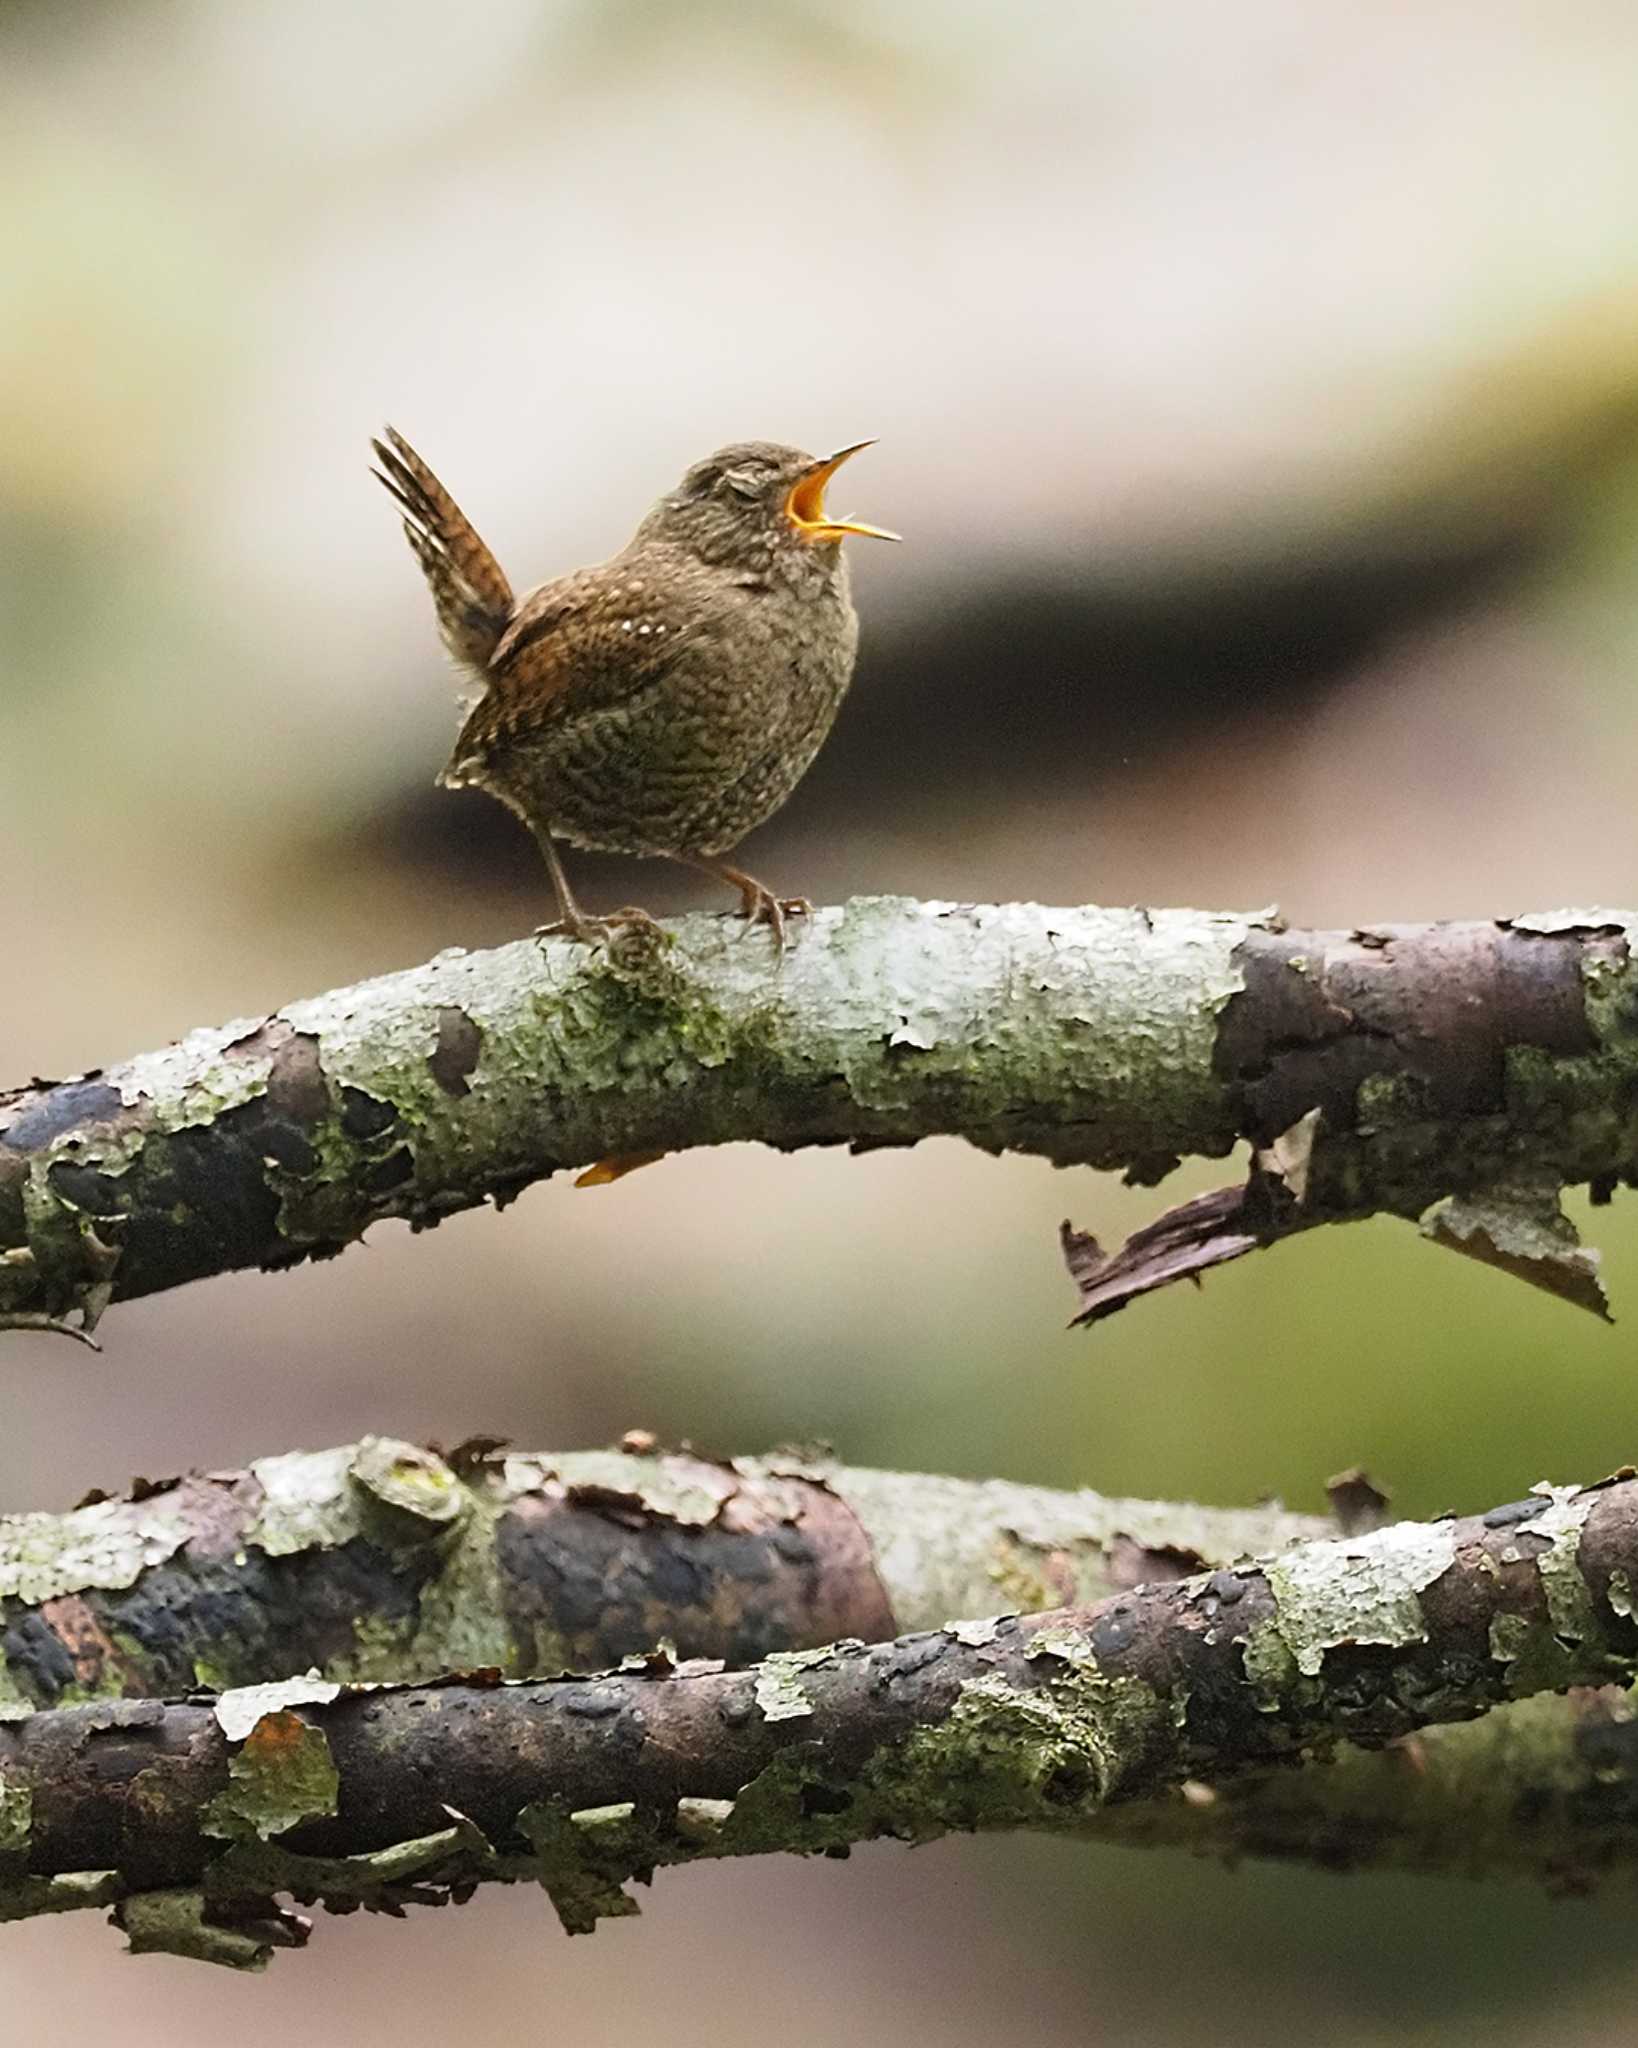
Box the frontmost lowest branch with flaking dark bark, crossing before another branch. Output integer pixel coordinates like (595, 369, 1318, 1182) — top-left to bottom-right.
(0, 1479, 1638, 1962)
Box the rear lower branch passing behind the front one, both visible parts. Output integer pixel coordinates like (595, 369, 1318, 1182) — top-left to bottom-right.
(0, 1436, 1638, 1911)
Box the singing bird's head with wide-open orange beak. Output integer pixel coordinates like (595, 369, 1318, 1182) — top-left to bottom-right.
(639, 440, 899, 580)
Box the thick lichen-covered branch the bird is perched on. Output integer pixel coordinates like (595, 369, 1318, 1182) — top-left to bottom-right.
(0, 899, 1638, 1327)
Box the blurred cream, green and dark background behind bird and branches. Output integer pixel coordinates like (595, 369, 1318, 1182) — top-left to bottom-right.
(0, 0, 1638, 2048)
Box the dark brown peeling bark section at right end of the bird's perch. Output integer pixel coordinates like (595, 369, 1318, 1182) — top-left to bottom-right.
(1063, 909, 1634, 1323)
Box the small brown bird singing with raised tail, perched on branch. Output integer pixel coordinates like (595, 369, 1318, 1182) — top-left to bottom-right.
(373, 428, 899, 944)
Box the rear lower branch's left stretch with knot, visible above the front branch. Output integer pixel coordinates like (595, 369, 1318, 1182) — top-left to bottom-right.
(0, 1438, 1325, 1720)
